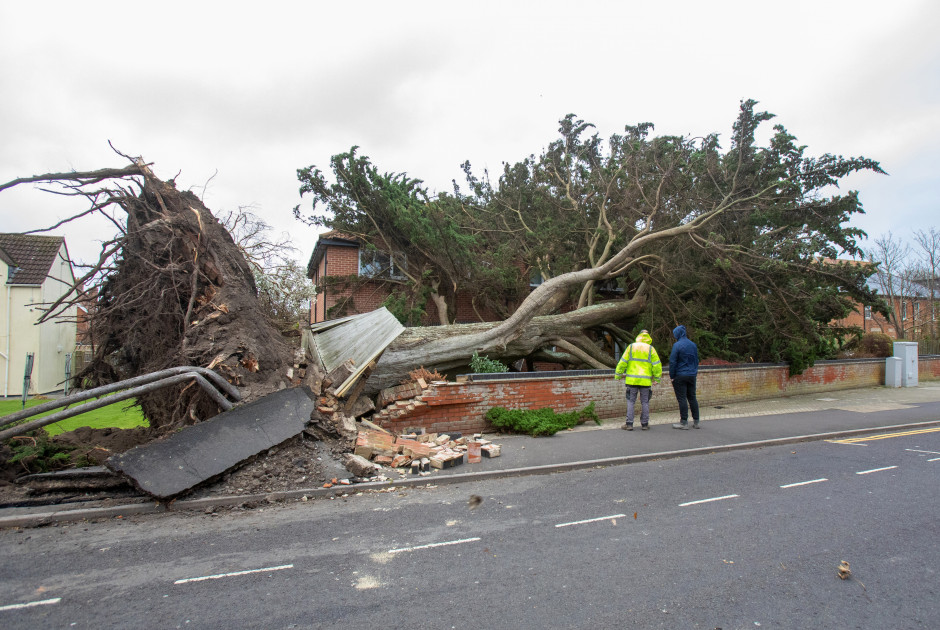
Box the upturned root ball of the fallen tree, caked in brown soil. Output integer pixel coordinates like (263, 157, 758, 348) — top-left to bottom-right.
(0, 155, 293, 434)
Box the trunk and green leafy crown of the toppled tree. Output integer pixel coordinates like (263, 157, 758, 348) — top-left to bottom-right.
(295, 101, 883, 389)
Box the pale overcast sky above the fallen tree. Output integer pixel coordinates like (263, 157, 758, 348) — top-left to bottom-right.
(0, 0, 940, 262)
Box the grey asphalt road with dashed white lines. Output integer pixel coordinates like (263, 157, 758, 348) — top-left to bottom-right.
(0, 427, 940, 630)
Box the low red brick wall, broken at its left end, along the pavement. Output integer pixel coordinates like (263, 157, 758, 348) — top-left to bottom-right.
(380, 357, 940, 434)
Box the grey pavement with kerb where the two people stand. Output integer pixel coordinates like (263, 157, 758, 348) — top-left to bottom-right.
(0, 381, 940, 528)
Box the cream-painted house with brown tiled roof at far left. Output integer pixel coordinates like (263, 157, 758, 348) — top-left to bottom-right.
(0, 234, 76, 396)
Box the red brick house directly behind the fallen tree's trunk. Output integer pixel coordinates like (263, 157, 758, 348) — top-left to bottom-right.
(307, 230, 501, 324)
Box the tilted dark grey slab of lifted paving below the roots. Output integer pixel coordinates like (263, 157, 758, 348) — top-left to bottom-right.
(105, 387, 316, 499)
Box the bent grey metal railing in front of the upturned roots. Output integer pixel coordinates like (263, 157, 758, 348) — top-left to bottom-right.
(0, 365, 242, 440)
